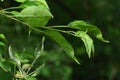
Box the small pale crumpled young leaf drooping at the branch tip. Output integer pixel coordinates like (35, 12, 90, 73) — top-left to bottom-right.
(75, 31, 94, 58)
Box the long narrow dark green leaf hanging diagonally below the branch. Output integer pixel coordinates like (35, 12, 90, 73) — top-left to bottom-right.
(45, 30, 80, 64)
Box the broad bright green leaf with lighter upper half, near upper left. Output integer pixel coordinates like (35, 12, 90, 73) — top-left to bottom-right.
(15, 5, 52, 27)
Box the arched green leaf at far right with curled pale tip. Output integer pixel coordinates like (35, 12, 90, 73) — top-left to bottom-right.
(68, 20, 109, 43)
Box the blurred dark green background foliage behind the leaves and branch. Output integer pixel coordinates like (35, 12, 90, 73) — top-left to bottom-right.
(0, 0, 120, 80)
